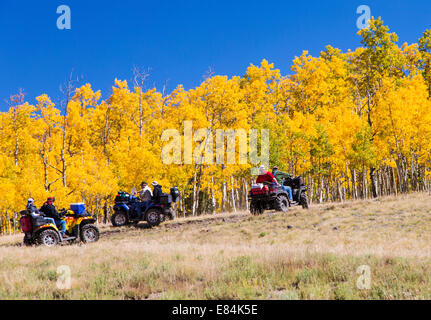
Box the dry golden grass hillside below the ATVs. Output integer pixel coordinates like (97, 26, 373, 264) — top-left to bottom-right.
(0, 193, 431, 299)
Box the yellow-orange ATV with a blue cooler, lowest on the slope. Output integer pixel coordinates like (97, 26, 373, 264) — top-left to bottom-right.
(20, 205, 100, 247)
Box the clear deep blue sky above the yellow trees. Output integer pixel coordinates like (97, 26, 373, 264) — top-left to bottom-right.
(0, 0, 431, 111)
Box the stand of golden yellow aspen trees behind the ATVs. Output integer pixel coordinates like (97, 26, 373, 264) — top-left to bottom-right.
(0, 19, 431, 230)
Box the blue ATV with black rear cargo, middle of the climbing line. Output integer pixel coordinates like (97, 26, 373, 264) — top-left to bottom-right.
(111, 187, 179, 227)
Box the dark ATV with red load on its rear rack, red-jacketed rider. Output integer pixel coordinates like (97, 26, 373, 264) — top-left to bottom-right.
(248, 182, 289, 215)
